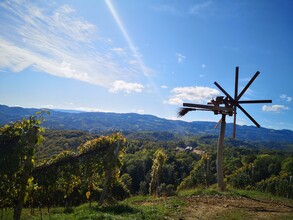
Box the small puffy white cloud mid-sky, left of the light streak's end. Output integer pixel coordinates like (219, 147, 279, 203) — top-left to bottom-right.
(109, 80, 144, 94)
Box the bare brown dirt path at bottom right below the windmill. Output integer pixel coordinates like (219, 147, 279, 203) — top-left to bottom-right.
(179, 195, 293, 220)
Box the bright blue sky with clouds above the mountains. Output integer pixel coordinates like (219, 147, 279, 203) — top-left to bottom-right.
(0, 0, 293, 130)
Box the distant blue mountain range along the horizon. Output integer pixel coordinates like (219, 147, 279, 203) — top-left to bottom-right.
(0, 105, 293, 144)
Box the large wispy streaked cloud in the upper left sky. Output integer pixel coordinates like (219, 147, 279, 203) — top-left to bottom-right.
(0, 0, 147, 91)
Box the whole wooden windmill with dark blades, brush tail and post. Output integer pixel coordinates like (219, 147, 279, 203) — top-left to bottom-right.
(178, 67, 272, 190)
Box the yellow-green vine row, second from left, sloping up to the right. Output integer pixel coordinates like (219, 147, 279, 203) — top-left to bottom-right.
(30, 133, 129, 207)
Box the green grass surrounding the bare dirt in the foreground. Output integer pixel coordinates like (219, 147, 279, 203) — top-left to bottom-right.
(0, 186, 293, 220)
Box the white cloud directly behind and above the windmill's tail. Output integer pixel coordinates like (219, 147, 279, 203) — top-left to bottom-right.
(164, 86, 219, 105)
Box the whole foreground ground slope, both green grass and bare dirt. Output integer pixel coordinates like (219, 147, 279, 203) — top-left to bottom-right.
(0, 189, 293, 219)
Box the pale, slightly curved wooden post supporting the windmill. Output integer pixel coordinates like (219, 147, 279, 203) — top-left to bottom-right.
(217, 114, 226, 191)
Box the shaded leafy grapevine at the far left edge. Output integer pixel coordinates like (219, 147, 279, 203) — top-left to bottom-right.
(0, 114, 44, 219)
